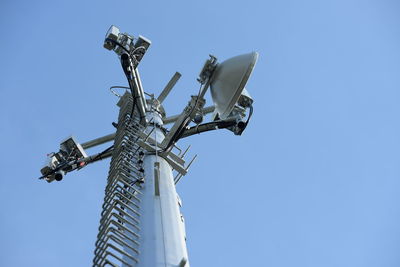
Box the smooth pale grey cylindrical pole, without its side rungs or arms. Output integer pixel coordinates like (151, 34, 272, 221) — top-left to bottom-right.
(125, 108, 189, 267)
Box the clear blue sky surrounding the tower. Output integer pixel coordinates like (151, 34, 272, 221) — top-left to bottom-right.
(0, 0, 400, 267)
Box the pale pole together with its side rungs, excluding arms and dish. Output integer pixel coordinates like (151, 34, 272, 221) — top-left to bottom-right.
(93, 94, 189, 267)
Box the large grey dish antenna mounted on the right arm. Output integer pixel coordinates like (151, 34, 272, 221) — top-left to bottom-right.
(210, 52, 258, 119)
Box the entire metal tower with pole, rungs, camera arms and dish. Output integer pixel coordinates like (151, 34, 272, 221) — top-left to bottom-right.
(40, 26, 258, 267)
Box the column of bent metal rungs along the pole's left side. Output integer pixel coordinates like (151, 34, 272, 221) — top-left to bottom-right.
(93, 96, 144, 267)
